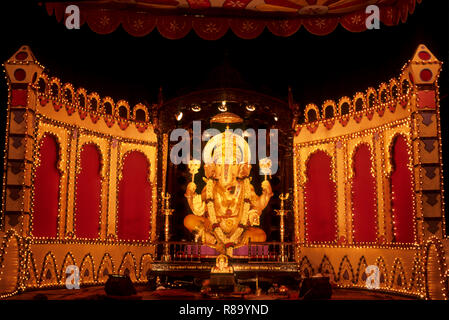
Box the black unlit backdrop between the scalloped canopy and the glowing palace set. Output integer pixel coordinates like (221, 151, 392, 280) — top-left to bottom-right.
(0, 0, 449, 235)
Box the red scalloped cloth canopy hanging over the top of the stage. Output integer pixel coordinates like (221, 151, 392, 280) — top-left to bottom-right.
(46, 0, 421, 40)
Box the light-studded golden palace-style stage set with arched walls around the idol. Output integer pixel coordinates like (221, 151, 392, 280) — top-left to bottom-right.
(0, 42, 449, 299)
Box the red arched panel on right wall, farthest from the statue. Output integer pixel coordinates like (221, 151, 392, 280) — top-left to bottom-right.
(391, 136, 414, 243)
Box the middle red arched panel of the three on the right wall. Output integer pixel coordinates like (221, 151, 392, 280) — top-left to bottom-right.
(352, 144, 377, 242)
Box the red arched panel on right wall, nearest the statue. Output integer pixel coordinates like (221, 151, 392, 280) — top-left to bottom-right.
(305, 151, 337, 242)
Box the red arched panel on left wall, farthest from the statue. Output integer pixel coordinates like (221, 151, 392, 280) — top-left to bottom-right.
(33, 135, 60, 237)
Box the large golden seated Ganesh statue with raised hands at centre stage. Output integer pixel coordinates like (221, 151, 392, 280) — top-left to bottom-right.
(184, 119, 273, 256)
